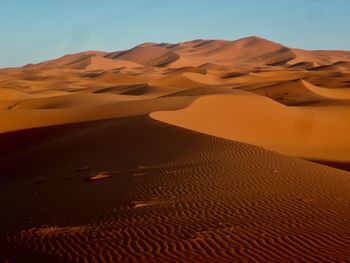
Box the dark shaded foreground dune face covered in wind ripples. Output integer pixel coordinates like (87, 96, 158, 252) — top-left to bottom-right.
(0, 117, 350, 262)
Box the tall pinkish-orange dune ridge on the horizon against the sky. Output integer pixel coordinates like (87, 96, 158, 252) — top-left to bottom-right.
(17, 36, 350, 73)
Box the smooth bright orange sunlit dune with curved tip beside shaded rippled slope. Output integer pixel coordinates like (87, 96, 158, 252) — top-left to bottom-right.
(150, 93, 350, 162)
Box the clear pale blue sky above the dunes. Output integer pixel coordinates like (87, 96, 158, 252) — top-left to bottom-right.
(0, 0, 350, 67)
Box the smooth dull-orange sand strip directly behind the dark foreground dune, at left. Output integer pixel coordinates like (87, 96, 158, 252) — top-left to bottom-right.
(0, 94, 194, 134)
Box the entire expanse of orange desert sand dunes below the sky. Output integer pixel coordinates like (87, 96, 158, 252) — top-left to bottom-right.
(0, 37, 350, 262)
